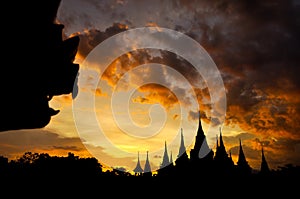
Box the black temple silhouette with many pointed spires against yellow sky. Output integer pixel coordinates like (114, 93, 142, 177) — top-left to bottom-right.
(133, 114, 270, 177)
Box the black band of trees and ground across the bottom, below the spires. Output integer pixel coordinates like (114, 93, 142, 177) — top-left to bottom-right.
(0, 152, 300, 198)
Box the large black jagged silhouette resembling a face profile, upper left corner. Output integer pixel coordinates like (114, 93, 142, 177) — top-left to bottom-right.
(0, 0, 79, 131)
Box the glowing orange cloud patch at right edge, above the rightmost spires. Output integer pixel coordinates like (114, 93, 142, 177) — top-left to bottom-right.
(226, 93, 300, 139)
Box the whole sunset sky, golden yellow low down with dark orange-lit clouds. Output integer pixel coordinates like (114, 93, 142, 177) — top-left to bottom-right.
(0, 0, 300, 173)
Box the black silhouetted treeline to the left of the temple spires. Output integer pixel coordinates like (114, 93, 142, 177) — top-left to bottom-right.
(0, 152, 130, 178)
